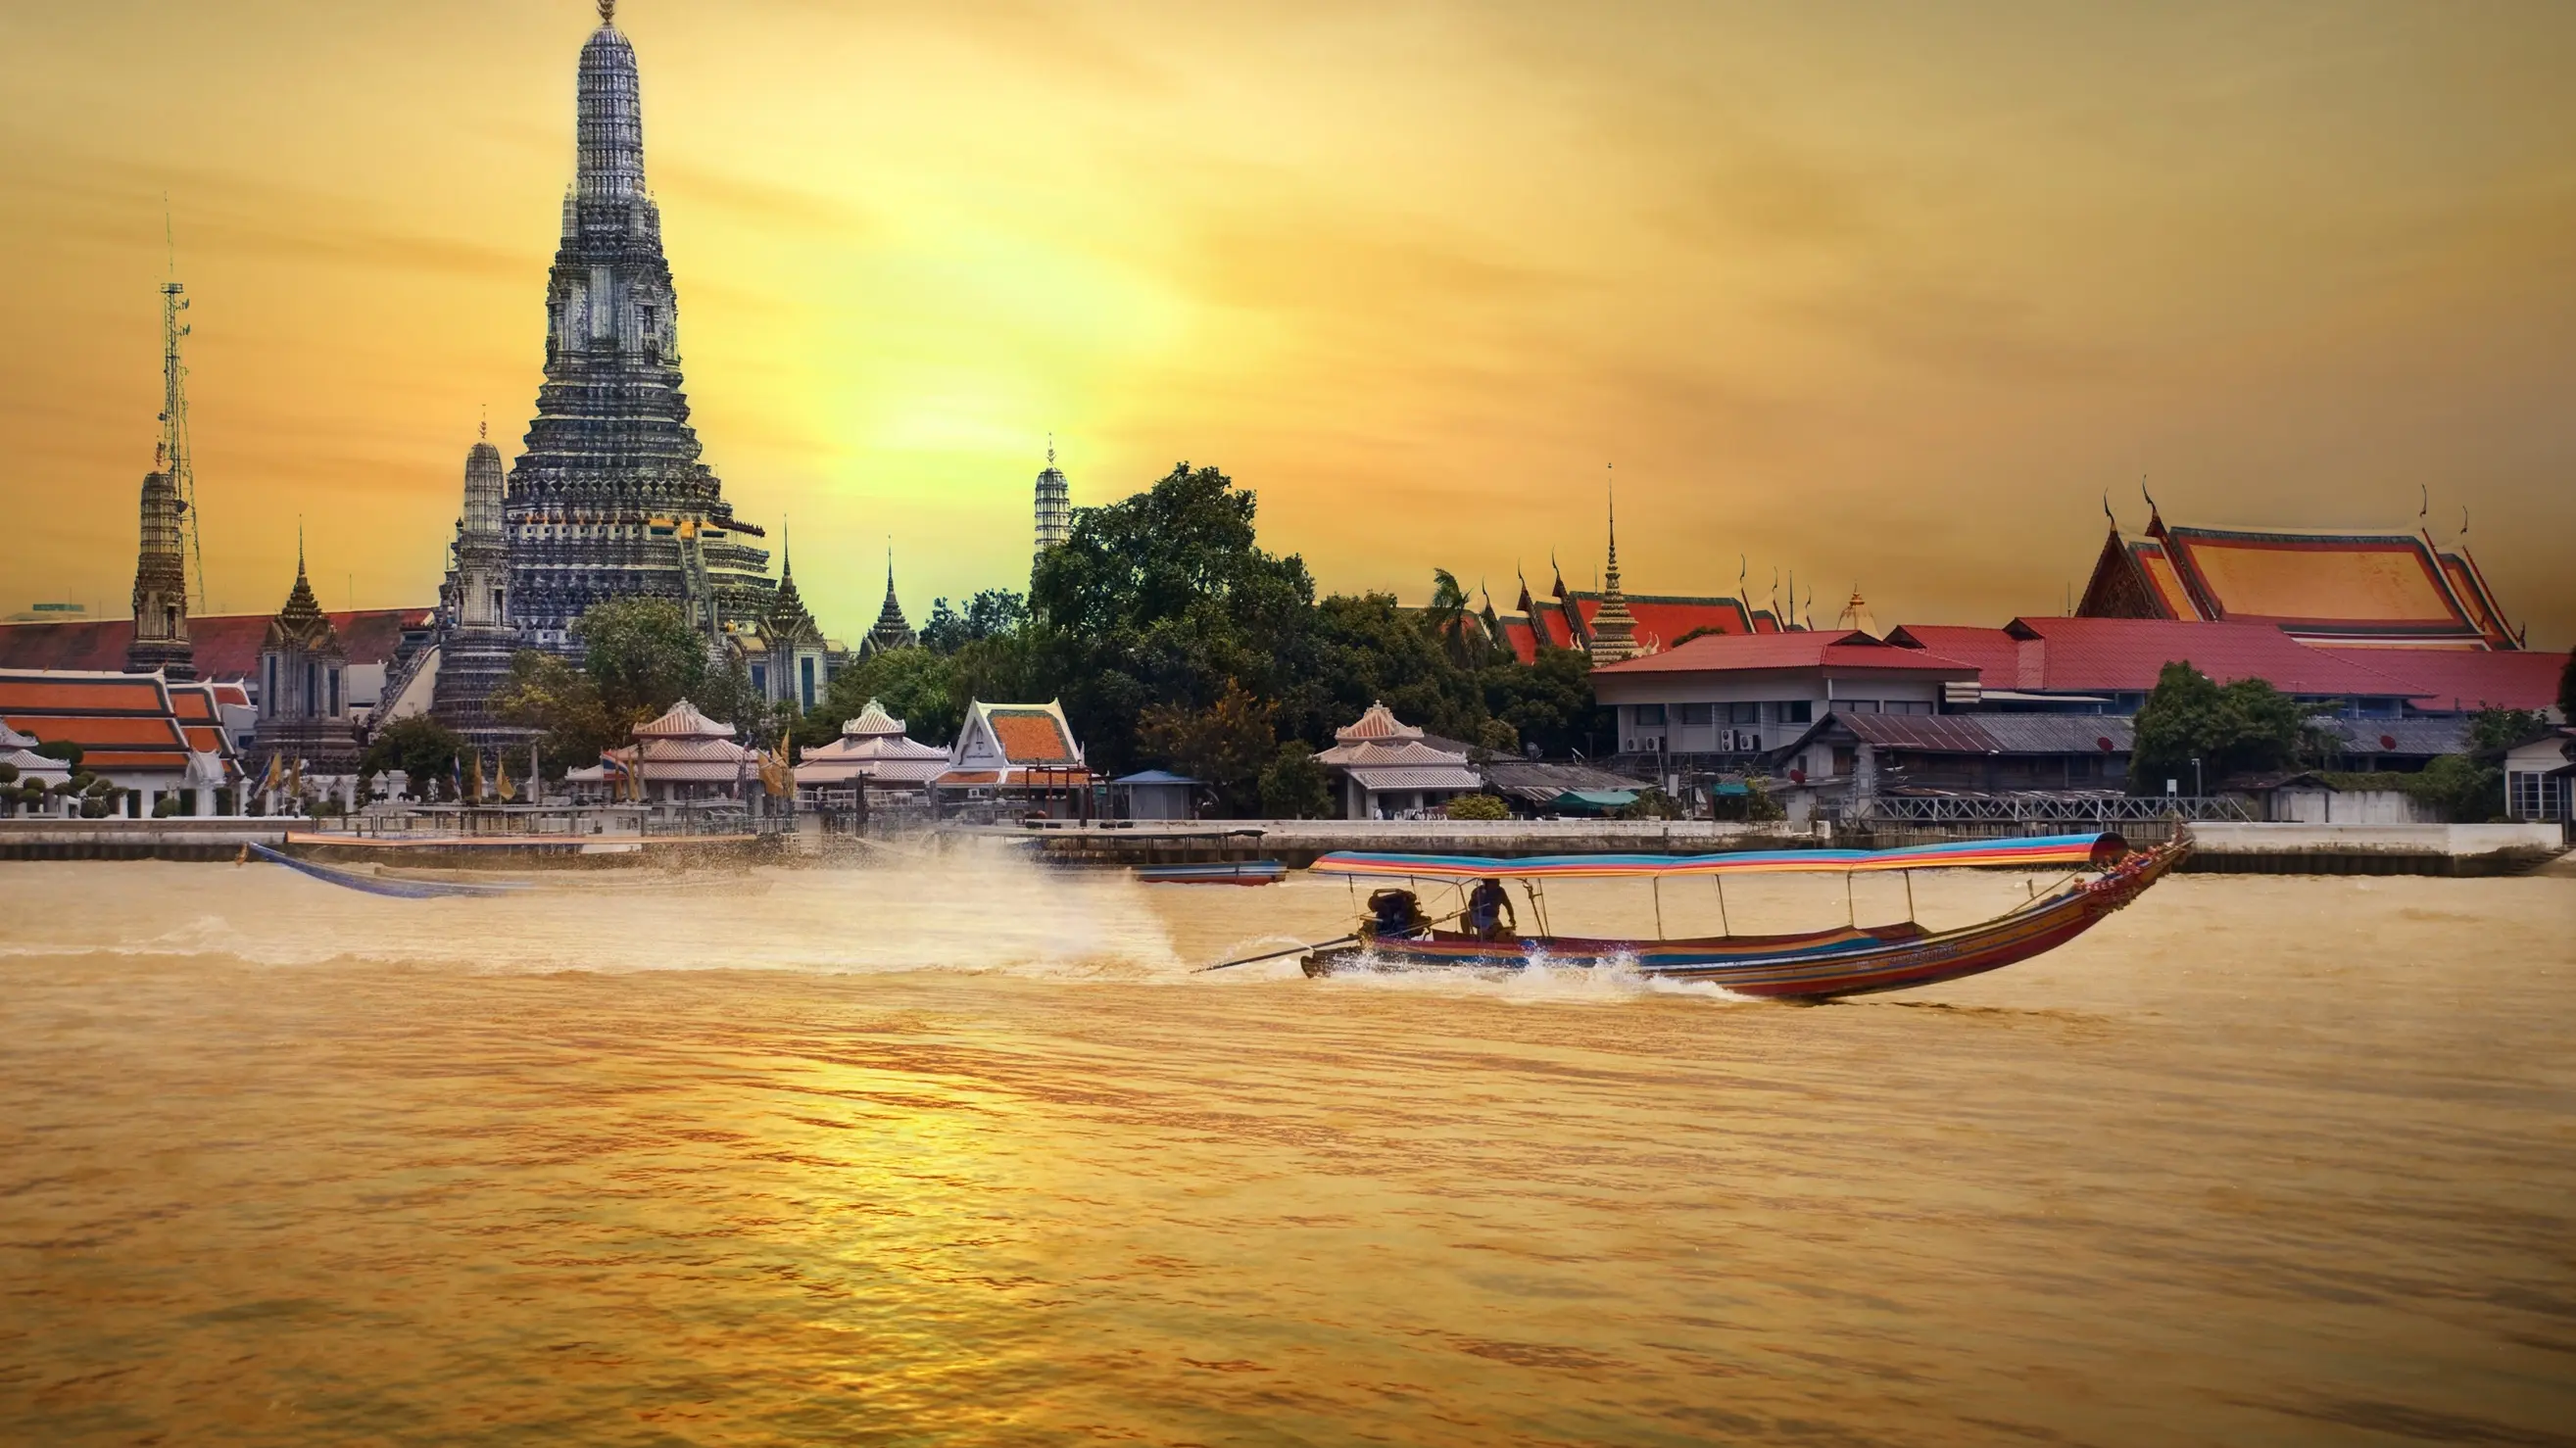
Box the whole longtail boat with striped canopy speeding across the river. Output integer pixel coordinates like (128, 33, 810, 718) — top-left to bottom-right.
(1303, 830, 2192, 999)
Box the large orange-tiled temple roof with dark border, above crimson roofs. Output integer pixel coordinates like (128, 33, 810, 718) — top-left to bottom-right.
(2076, 512, 2522, 650)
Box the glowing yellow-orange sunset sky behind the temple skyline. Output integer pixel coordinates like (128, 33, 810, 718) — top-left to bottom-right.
(0, 0, 2576, 647)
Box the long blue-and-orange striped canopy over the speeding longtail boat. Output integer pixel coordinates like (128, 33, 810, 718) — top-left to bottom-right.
(1314, 835, 2128, 881)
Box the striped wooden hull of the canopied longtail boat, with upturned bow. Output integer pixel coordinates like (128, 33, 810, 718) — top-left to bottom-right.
(1303, 840, 2190, 999)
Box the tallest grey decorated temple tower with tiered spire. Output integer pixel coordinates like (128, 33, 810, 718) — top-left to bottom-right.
(503, 0, 775, 652)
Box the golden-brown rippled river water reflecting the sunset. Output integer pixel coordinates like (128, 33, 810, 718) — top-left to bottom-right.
(0, 858, 2576, 1445)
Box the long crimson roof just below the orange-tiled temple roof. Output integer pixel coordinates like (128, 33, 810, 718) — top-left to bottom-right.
(1999, 618, 2419, 699)
